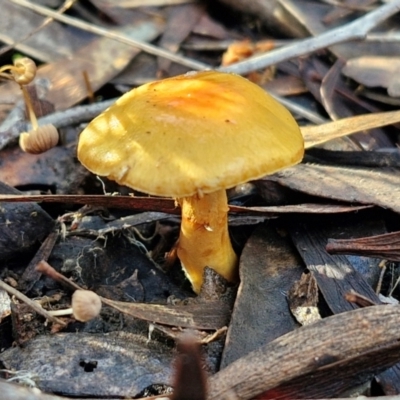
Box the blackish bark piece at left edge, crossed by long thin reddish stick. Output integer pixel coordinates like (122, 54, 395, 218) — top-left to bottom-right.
(0, 182, 54, 261)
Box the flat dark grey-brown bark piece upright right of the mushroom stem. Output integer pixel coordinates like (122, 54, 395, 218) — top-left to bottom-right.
(221, 225, 304, 368)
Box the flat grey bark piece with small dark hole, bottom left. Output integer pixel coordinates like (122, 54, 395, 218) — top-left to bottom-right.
(0, 332, 172, 398)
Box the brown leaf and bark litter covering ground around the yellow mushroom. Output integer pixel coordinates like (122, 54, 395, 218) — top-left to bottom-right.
(0, 0, 400, 400)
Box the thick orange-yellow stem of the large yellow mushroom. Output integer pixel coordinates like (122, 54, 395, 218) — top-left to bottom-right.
(177, 189, 238, 293)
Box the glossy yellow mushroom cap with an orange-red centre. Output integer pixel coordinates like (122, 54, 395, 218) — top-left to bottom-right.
(78, 71, 304, 197)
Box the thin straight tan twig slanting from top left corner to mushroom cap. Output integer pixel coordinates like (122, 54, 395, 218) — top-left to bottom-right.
(9, 0, 210, 70)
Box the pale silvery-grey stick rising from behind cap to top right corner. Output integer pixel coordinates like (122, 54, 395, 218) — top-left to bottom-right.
(219, 0, 400, 74)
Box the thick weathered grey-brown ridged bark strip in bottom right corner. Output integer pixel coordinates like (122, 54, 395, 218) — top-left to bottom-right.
(208, 305, 400, 400)
